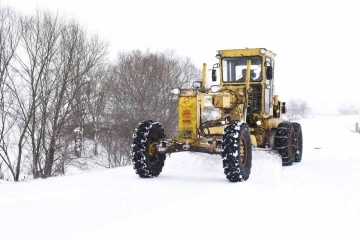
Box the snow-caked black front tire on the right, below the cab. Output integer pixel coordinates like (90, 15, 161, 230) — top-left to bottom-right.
(221, 121, 252, 182)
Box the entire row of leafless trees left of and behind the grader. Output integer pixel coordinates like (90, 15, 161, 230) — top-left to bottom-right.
(0, 6, 200, 181)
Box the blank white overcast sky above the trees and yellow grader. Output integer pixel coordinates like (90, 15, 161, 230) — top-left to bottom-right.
(0, 0, 360, 110)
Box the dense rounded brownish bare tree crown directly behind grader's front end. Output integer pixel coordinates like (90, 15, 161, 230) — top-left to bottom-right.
(112, 50, 200, 130)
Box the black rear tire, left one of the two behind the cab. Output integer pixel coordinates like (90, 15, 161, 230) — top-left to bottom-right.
(275, 122, 296, 166)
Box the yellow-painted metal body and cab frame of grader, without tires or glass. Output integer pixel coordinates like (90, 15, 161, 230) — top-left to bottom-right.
(172, 48, 282, 155)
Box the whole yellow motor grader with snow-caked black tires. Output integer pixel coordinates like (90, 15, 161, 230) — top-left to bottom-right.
(131, 48, 303, 182)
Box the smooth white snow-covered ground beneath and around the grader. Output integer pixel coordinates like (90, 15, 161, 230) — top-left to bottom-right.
(0, 116, 360, 240)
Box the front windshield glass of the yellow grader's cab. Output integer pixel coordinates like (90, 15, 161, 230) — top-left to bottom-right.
(222, 56, 262, 82)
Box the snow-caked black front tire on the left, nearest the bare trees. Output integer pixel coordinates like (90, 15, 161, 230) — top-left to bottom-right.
(131, 120, 166, 178)
